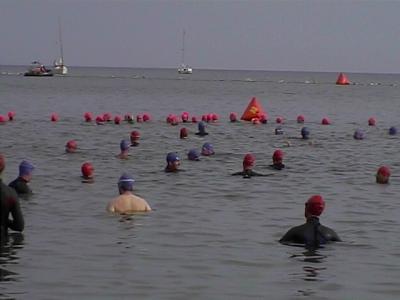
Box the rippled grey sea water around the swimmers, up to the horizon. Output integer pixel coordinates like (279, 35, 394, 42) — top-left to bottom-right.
(0, 66, 400, 300)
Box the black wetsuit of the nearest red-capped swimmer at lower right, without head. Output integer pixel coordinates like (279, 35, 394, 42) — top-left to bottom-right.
(279, 216, 341, 248)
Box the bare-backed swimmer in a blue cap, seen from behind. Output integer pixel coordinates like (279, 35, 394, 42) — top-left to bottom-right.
(106, 174, 151, 214)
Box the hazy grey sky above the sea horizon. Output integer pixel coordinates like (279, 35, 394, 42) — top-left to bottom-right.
(0, 0, 400, 73)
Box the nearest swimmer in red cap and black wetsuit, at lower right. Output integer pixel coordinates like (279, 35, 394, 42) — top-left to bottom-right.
(279, 195, 341, 249)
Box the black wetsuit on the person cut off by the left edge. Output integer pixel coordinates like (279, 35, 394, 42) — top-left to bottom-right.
(0, 180, 24, 242)
